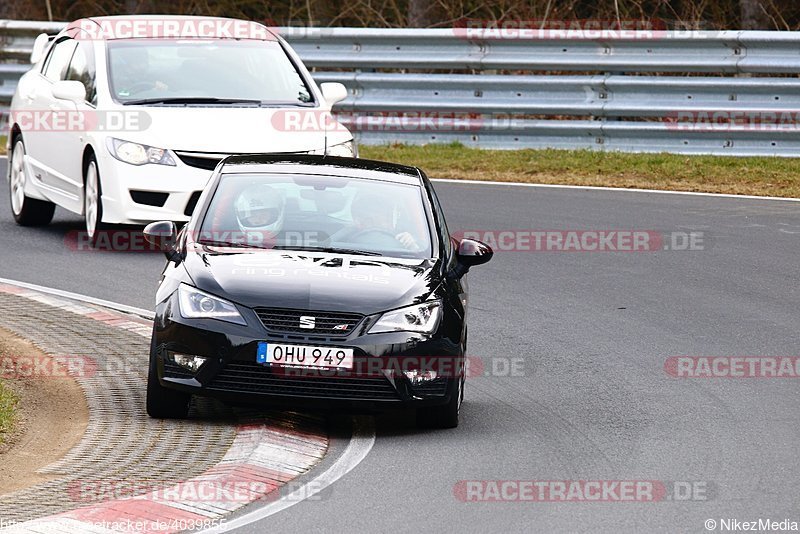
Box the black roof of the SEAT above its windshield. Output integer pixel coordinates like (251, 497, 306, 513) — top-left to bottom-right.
(218, 154, 422, 185)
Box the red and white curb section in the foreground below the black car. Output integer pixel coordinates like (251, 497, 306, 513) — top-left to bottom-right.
(3, 424, 327, 533)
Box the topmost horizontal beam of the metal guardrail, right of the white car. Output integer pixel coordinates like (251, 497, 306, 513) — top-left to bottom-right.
(287, 28, 800, 73)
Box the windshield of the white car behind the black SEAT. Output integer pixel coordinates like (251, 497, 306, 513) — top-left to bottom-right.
(106, 39, 313, 106)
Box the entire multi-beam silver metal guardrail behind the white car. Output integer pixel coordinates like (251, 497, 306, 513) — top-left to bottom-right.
(0, 21, 800, 156)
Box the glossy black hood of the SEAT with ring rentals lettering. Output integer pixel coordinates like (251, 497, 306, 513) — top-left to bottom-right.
(185, 245, 440, 315)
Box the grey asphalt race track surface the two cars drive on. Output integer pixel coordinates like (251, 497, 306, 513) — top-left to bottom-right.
(0, 160, 800, 533)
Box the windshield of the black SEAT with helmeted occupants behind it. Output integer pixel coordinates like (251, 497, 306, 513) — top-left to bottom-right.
(196, 174, 431, 258)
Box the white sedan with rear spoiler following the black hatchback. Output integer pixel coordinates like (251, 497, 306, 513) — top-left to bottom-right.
(8, 16, 357, 245)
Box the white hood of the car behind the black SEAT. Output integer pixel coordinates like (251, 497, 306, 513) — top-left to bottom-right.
(119, 106, 344, 154)
